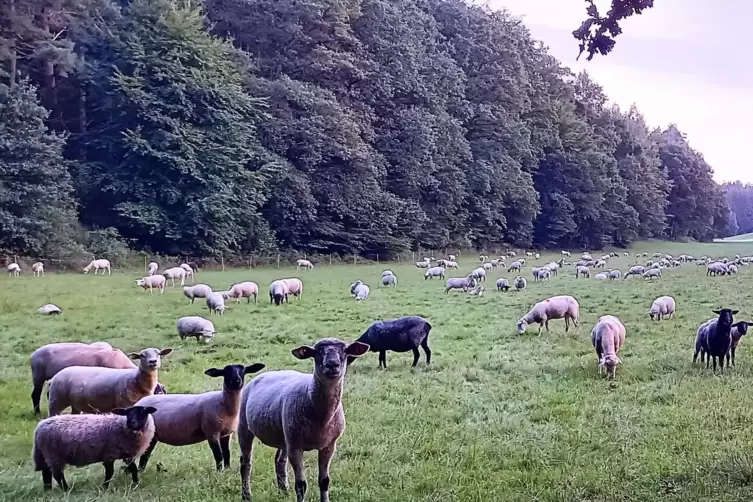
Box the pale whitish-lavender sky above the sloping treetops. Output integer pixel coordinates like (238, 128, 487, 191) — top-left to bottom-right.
(486, 0, 753, 183)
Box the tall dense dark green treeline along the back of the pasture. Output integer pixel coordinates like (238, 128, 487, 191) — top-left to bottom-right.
(0, 0, 730, 256)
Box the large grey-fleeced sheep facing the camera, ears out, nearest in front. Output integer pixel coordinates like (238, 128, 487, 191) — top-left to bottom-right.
(238, 338, 369, 502)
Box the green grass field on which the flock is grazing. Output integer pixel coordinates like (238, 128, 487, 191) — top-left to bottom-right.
(7, 242, 753, 502)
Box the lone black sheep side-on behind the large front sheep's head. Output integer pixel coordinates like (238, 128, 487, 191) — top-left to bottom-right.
(348, 316, 431, 369)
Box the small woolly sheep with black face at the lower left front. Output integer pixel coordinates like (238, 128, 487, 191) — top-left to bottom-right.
(32, 406, 157, 491)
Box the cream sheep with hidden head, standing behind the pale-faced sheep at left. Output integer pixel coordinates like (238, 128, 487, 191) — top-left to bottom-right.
(30, 342, 165, 415)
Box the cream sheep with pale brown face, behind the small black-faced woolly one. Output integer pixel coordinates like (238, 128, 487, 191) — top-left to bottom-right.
(49, 348, 173, 416)
